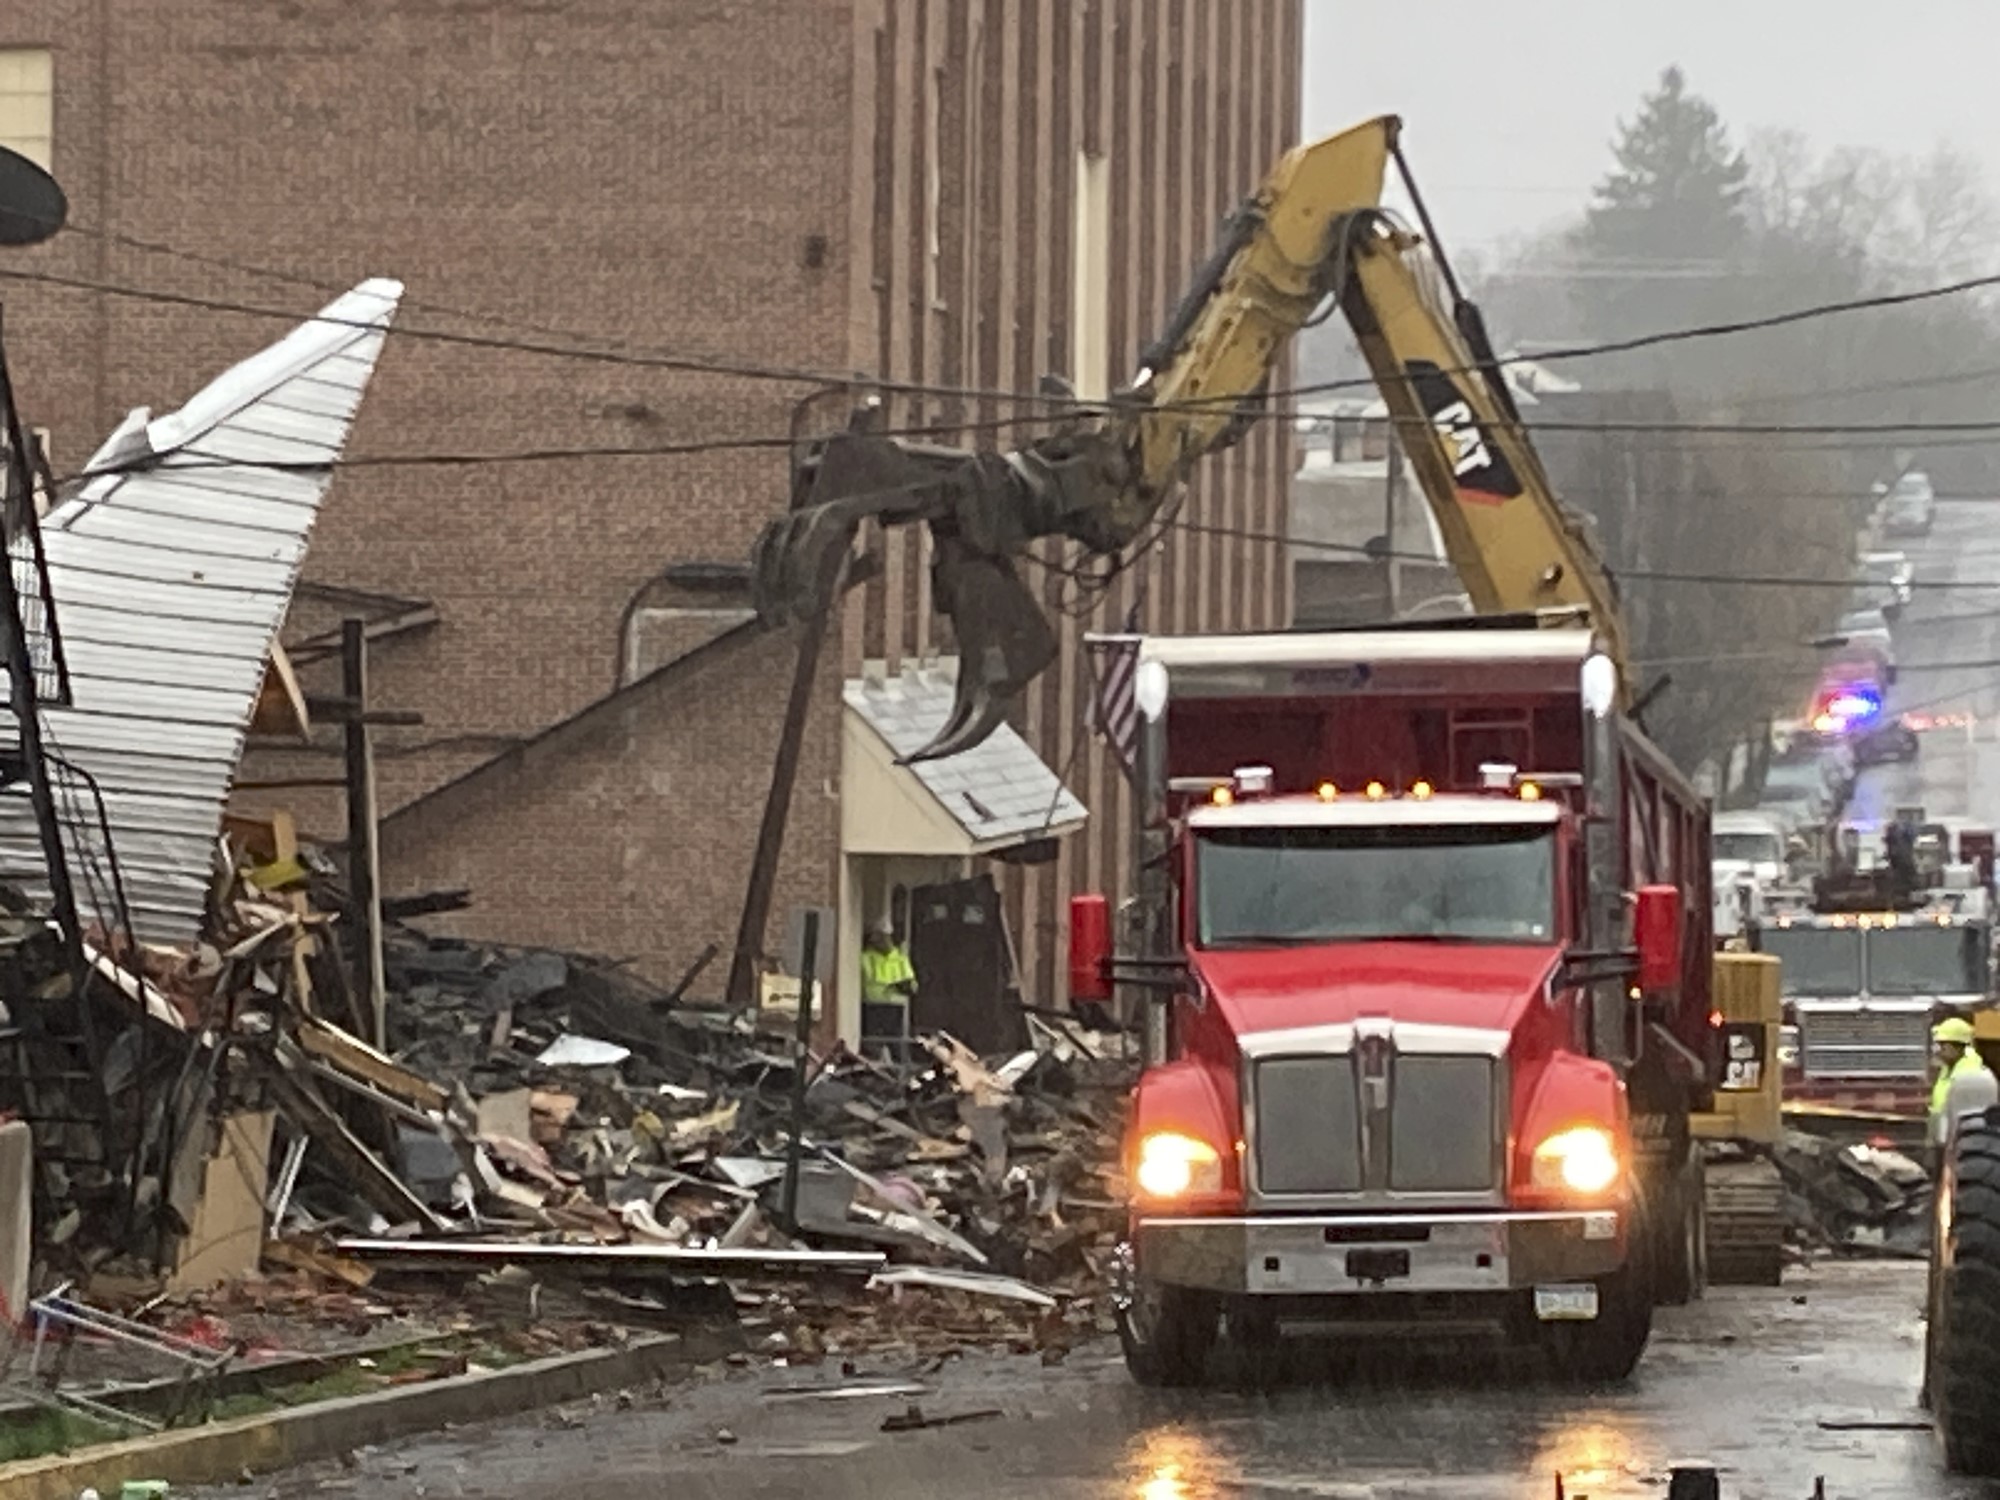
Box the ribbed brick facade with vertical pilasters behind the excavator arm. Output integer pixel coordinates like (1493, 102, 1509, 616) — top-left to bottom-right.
(848, 0, 1302, 1012)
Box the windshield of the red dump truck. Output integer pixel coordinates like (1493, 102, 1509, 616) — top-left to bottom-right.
(1196, 824, 1556, 948)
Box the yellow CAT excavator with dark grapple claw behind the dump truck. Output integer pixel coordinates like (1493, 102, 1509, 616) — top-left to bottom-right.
(752, 116, 1784, 1300)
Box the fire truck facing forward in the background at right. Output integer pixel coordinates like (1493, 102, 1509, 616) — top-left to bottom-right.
(1750, 808, 1994, 1120)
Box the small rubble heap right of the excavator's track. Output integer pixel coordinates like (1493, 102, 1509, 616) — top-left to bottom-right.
(1776, 1130, 1930, 1260)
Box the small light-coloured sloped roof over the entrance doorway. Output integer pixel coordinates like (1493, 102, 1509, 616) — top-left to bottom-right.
(844, 670, 1088, 848)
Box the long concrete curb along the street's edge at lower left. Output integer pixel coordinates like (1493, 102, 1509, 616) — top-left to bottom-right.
(0, 1336, 706, 1500)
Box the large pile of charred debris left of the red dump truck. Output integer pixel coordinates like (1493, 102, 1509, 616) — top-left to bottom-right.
(7, 846, 1132, 1358)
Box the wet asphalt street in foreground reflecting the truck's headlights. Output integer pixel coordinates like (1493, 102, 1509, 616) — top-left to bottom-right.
(214, 1262, 1976, 1500)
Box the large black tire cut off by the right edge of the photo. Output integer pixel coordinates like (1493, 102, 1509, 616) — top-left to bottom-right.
(1926, 1110, 2000, 1478)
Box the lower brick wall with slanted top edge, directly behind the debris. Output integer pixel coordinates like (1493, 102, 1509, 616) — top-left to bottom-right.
(382, 632, 840, 996)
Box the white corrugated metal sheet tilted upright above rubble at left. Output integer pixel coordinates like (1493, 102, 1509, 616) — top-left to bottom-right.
(0, 280, 402, 944)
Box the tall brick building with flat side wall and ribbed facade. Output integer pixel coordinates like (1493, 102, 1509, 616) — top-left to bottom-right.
(0, 0, 1300, 1032)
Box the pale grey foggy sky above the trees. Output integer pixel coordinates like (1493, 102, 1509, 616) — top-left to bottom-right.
(1304, 0, 2000, 262)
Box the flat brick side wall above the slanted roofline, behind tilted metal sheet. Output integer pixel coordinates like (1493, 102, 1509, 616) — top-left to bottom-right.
(0, 0, 850, 826)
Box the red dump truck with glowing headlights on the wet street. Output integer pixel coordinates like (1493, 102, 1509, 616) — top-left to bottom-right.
(1072, 616, 1742, 1384)
